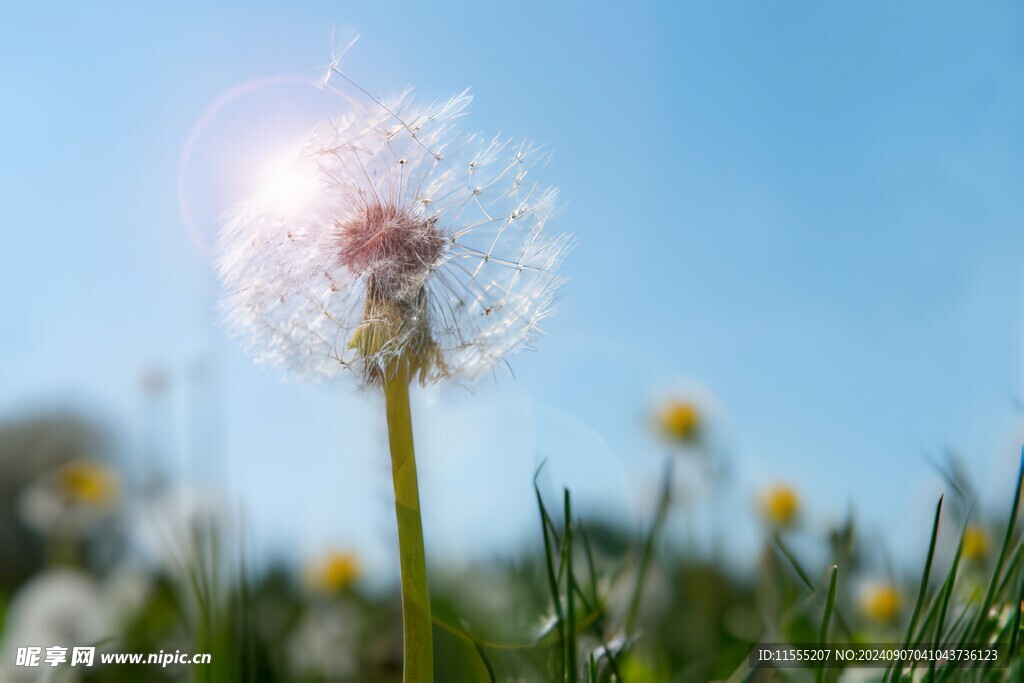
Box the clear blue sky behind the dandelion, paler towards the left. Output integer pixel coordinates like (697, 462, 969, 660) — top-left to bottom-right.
(0, 2, 1024, 581)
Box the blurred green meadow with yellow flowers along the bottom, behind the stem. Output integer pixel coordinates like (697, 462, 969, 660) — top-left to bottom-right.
(0, 401, 1024, 682)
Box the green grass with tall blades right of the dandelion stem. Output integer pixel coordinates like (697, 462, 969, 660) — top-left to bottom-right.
(205, 450, 1024, 683)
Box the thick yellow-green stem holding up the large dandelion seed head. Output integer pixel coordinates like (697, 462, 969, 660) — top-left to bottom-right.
(384, 360, 434, 683)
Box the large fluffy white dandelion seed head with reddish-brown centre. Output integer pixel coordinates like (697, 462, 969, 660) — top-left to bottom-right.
(218, 72, 568, 383)
